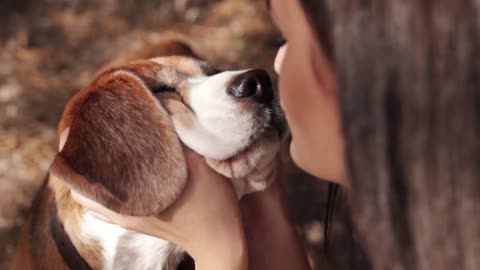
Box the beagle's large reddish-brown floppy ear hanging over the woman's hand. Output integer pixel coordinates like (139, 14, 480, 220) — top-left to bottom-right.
(50, 71, 187, 216)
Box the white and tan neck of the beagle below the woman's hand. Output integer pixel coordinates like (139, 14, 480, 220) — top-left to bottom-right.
(49, 176, 183, 270)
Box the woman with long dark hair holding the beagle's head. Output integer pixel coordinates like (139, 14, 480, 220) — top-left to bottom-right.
(69, 0, 480, 269)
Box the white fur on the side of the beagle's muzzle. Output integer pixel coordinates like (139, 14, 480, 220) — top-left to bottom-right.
(174, 70, 255, 159)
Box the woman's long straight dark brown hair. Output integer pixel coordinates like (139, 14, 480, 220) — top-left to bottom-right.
(300, 0, 480, 270)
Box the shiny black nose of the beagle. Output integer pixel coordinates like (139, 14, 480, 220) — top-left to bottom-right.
(228, 69, 273, 102)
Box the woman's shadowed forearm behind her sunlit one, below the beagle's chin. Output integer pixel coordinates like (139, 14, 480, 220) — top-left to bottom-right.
(241, 179, 310, 270)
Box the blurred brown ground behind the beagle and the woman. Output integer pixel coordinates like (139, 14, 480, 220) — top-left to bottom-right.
(0, 0, 342, 270)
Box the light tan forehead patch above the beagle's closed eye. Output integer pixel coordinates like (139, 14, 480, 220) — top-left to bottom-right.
(151, 56, 208, 77)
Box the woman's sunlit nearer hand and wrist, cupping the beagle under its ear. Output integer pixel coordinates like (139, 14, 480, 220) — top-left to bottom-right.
(61, 130, 247, 270)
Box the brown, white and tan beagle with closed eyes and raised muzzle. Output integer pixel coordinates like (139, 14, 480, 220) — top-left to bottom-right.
(12, 41, 287, 270)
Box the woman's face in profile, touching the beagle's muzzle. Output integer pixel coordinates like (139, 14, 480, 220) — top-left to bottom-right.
(270, 0, 345, 184)
